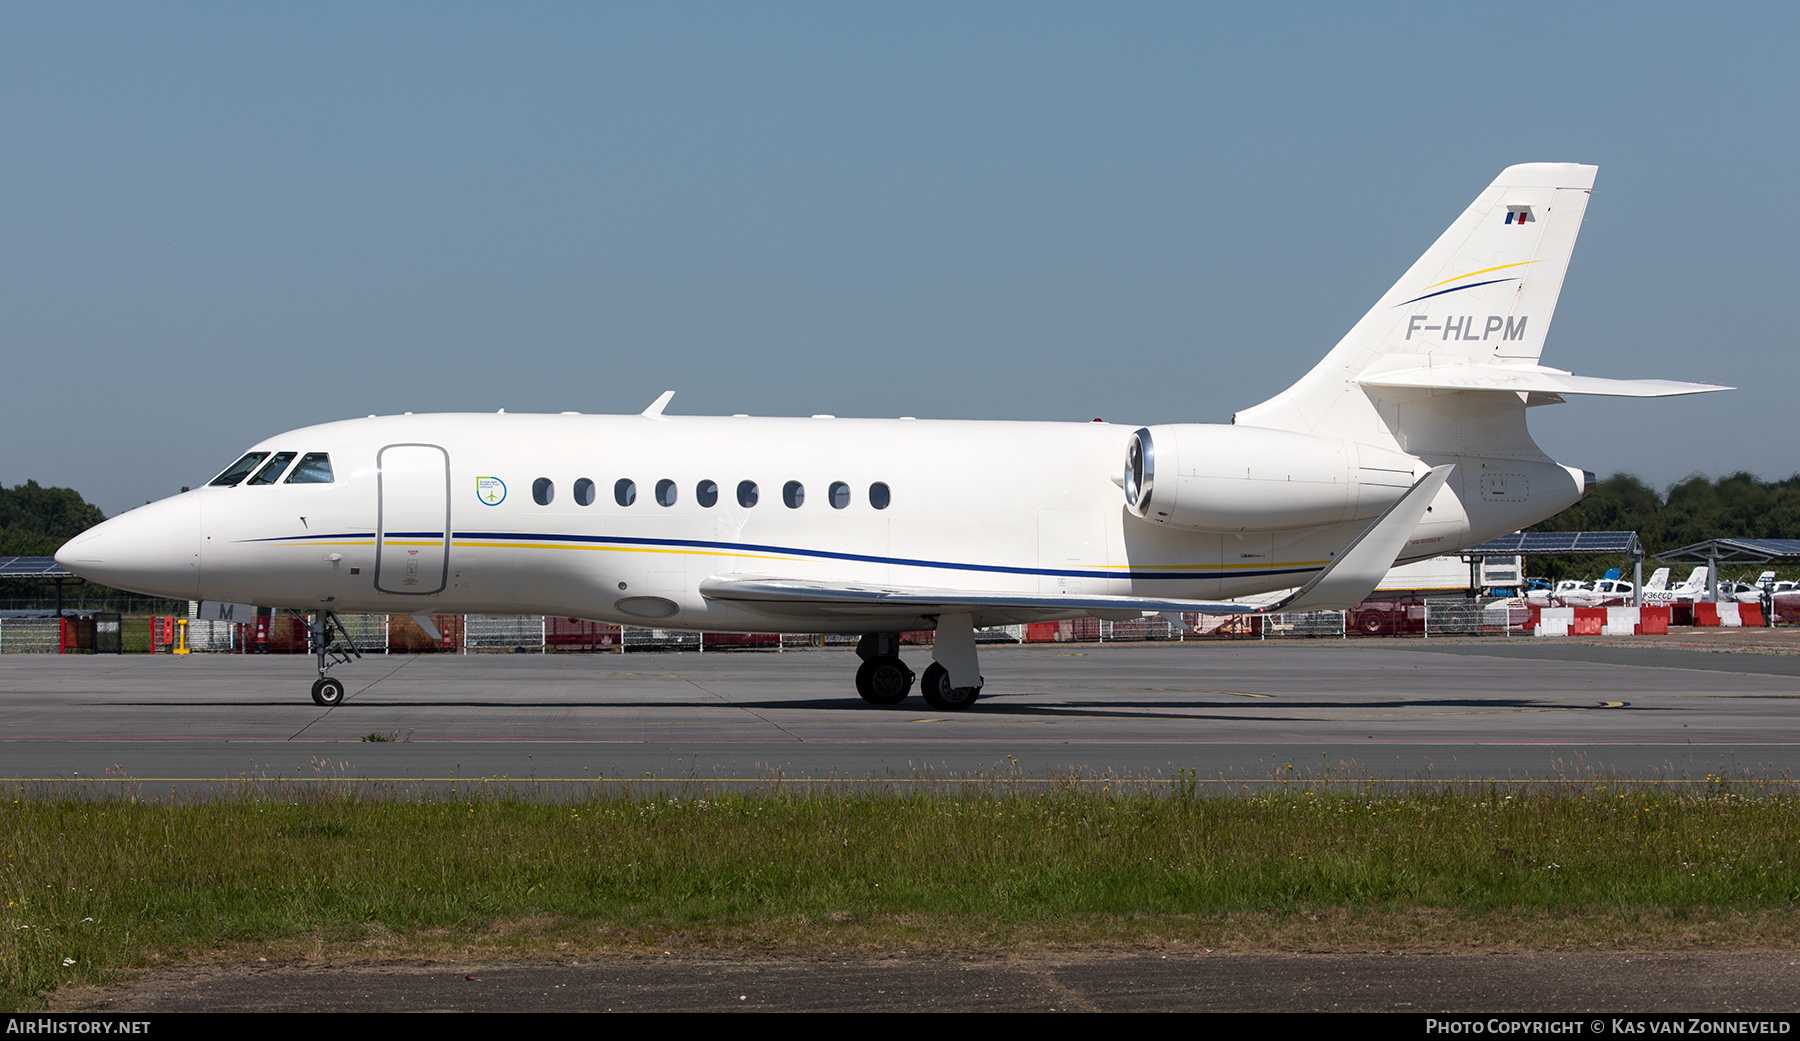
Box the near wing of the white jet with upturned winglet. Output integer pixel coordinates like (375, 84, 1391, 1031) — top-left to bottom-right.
(700, 463, 1454, 625)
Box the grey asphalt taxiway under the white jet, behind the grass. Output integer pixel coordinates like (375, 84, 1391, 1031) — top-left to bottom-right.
(0, 639, 1800, 785)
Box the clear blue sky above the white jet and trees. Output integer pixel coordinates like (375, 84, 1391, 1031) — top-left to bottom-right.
(0, 4, 1800, 513)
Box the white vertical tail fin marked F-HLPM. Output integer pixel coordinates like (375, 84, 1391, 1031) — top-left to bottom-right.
(1235, 162, 1597, 452)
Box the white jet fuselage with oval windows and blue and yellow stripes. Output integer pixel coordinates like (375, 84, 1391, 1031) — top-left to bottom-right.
(65, 414, 1580, 632)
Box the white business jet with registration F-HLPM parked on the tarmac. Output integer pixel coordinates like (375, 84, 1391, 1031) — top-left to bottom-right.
(56, 164, 1728, 710)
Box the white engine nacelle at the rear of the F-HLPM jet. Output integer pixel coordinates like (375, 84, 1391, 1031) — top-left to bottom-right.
(1125, 423, 1424, 531)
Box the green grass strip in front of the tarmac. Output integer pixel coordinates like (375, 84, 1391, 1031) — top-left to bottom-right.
(0, 783, 1800, 1009)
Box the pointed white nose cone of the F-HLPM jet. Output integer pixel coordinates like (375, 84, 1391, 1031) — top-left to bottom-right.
(56, 492, 200, 600)
